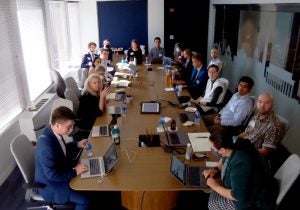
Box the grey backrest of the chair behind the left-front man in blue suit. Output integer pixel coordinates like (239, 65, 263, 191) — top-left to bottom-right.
(10, 134, 35, 183)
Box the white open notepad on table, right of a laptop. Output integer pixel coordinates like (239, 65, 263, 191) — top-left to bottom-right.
(188, 132, 211, 152)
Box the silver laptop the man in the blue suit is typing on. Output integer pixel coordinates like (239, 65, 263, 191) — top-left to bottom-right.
(80, 143, 119, 178)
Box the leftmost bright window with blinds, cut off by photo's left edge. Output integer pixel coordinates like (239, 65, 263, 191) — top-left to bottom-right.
(0, 1, 22, 129)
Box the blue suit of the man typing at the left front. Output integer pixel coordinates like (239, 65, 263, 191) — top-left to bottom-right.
(35, 127, 76, 203)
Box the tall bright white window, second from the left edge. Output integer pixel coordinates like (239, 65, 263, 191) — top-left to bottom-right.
(17, 0, 51, 101)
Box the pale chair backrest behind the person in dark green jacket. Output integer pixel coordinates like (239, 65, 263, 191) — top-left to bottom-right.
(274, 154, 300, 205)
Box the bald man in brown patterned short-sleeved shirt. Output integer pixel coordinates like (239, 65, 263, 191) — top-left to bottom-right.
(239, 93, 283, 156)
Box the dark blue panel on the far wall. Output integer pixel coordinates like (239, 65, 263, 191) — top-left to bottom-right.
(97, 0, 148, 49)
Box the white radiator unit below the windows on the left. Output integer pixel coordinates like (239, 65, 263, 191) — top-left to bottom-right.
(19, 93, 57, 142)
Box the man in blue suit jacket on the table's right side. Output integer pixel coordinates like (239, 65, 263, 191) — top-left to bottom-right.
(187, 54, 208, 99)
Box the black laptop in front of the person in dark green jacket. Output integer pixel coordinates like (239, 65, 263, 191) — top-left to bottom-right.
(170, 154, 209, 189)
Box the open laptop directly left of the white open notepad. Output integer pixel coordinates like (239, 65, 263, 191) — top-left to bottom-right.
(164, 128, 190, 147)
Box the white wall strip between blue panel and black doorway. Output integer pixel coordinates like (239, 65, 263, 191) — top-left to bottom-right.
(148, 0, 165, 52)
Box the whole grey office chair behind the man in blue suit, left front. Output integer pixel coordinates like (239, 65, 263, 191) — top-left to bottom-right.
(10, 134, 74, 210)
